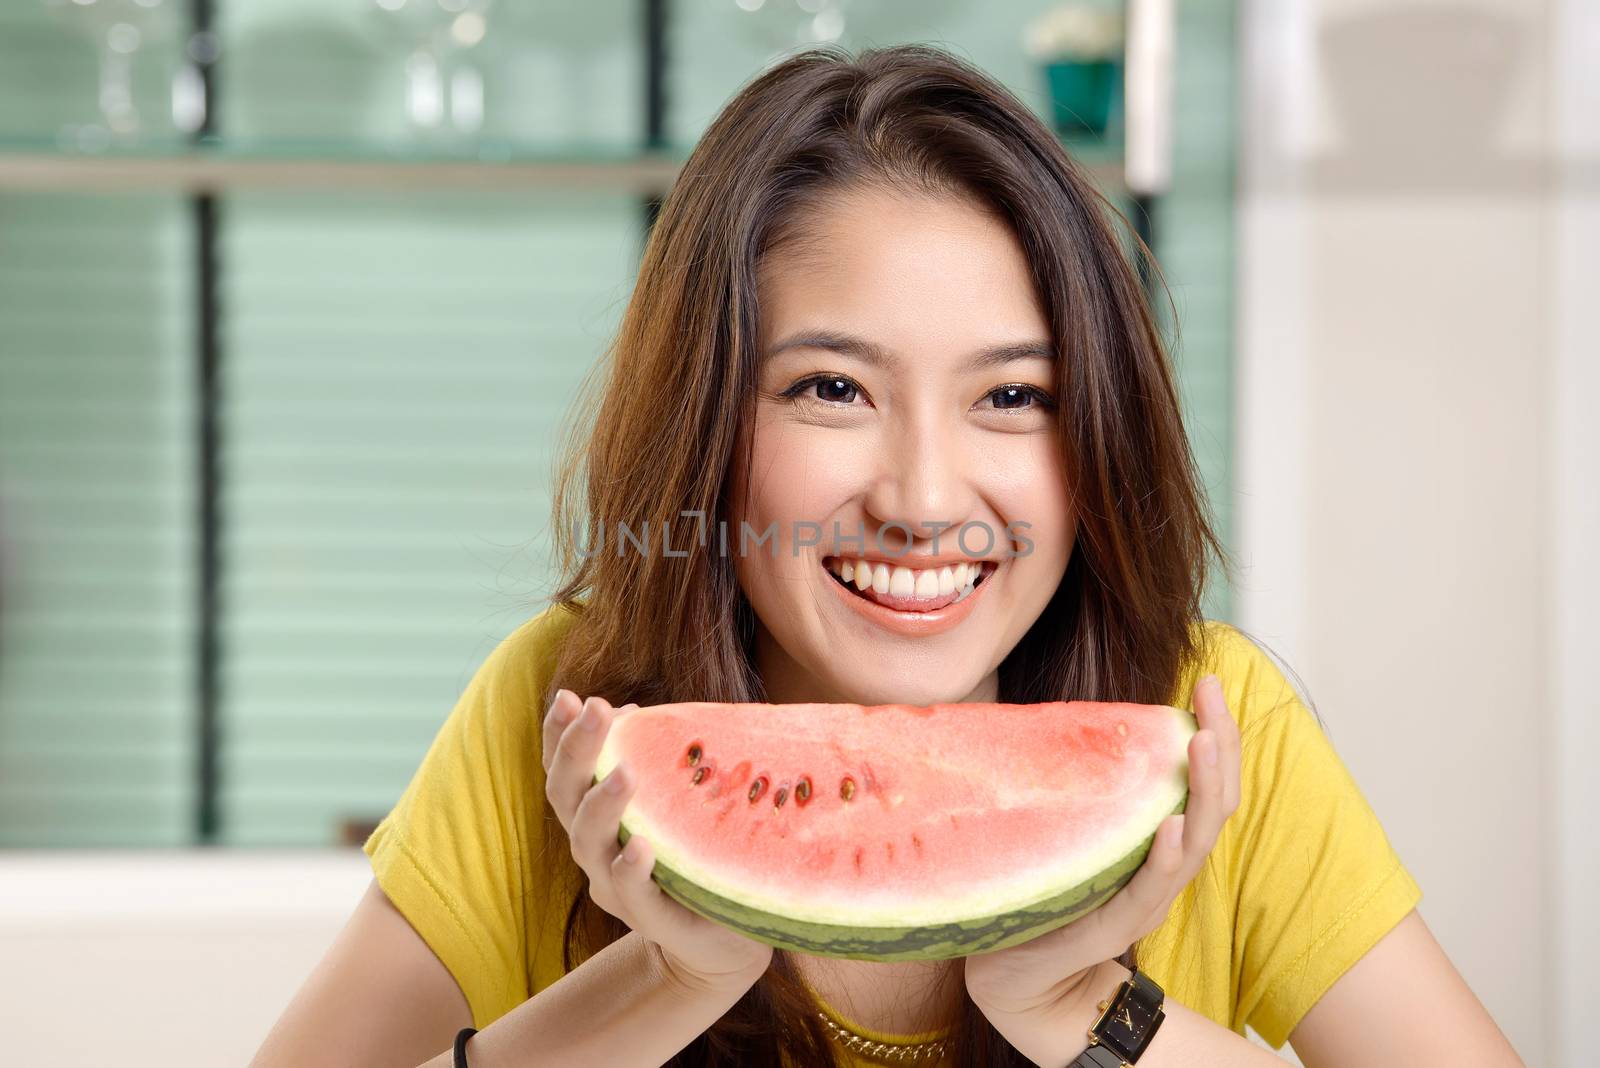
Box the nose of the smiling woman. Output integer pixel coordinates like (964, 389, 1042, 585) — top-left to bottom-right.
(864, 420, 974, 552)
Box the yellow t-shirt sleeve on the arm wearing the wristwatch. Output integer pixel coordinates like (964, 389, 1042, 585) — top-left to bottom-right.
(1219, 628, 1422, 1047)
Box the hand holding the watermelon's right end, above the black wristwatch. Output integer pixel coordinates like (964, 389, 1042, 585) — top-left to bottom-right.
(965, 675, 1238, 1031)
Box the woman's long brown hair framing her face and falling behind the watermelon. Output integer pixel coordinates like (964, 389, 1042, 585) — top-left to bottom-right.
(544, 45, 1227, 1068)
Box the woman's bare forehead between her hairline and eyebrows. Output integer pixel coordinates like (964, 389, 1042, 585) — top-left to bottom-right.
(757, 190, 1050, 357)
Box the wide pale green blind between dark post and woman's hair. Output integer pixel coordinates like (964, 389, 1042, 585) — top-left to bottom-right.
(221, 193, 640, 844)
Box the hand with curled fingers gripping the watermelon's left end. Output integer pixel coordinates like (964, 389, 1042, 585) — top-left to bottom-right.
(542, 689, 773, 990)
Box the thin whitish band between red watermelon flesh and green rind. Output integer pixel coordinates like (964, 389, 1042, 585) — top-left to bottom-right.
(595, 708, 1197, 927)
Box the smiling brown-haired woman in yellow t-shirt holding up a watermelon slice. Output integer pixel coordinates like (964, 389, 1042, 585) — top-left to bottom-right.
(256, 48, 1518, 1068)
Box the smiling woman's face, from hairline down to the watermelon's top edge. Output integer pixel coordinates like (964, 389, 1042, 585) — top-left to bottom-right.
(728, 190, 1075, 705)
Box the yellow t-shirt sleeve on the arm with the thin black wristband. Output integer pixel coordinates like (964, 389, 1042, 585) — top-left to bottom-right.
(362, 608, 565, 1028)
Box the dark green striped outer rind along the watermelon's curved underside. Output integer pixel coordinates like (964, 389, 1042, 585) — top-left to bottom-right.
(618, 791, 1189, 961)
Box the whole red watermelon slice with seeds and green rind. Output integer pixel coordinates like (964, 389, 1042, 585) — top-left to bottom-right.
(595, 702, 1197, 961)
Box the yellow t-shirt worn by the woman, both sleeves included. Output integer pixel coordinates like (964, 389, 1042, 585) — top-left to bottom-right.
(363, 608, 1422, 1065)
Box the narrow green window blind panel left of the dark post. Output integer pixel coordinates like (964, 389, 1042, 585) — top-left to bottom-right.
(0, 195, 195, 846)
